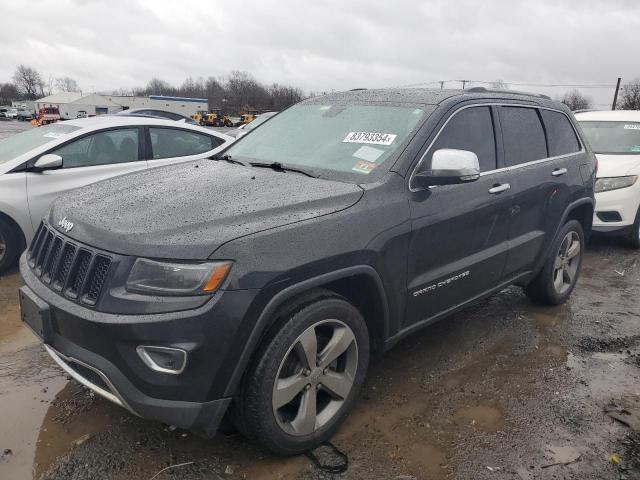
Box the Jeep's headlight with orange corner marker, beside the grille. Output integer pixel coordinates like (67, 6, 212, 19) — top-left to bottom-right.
(127, 258, 231, 295)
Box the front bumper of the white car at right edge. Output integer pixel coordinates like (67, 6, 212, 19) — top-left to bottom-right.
(593, 182, 640, 232)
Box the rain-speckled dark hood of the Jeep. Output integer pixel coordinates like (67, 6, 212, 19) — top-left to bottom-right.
(49, 160, 363, 259)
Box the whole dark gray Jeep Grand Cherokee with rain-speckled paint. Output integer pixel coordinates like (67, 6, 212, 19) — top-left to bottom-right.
(20, 89, 596, 454)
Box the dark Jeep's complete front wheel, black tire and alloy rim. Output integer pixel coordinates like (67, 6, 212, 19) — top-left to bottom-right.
(235, 290, 369, 455)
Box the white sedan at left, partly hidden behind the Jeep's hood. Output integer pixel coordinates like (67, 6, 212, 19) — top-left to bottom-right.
(0, 116, 233, 272)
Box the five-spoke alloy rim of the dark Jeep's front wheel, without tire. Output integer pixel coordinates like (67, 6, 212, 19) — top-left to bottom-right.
(272, 319, 358, 436)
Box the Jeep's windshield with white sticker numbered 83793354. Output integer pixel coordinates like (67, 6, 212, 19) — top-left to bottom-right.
(225, 105, 426, 181)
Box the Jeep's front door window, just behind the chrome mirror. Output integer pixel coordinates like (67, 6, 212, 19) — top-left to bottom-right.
(428, 107, 496, 172)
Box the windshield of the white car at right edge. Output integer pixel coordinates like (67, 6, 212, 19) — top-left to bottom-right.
(580, 122, 640, 154)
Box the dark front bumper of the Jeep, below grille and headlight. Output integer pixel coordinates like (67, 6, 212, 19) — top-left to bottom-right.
(20, 255, 255, 435)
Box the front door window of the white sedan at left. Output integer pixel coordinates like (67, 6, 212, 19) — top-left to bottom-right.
(51, 128, 138, 168)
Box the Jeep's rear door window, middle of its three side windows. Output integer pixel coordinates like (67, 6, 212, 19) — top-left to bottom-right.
(500, 106, 548, 166)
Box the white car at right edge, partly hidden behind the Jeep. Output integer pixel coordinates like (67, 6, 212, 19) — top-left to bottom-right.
(576, 110, 640, 248)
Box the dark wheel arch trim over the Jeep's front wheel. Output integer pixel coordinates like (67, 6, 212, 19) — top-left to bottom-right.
(225, 265, 389, 397)
